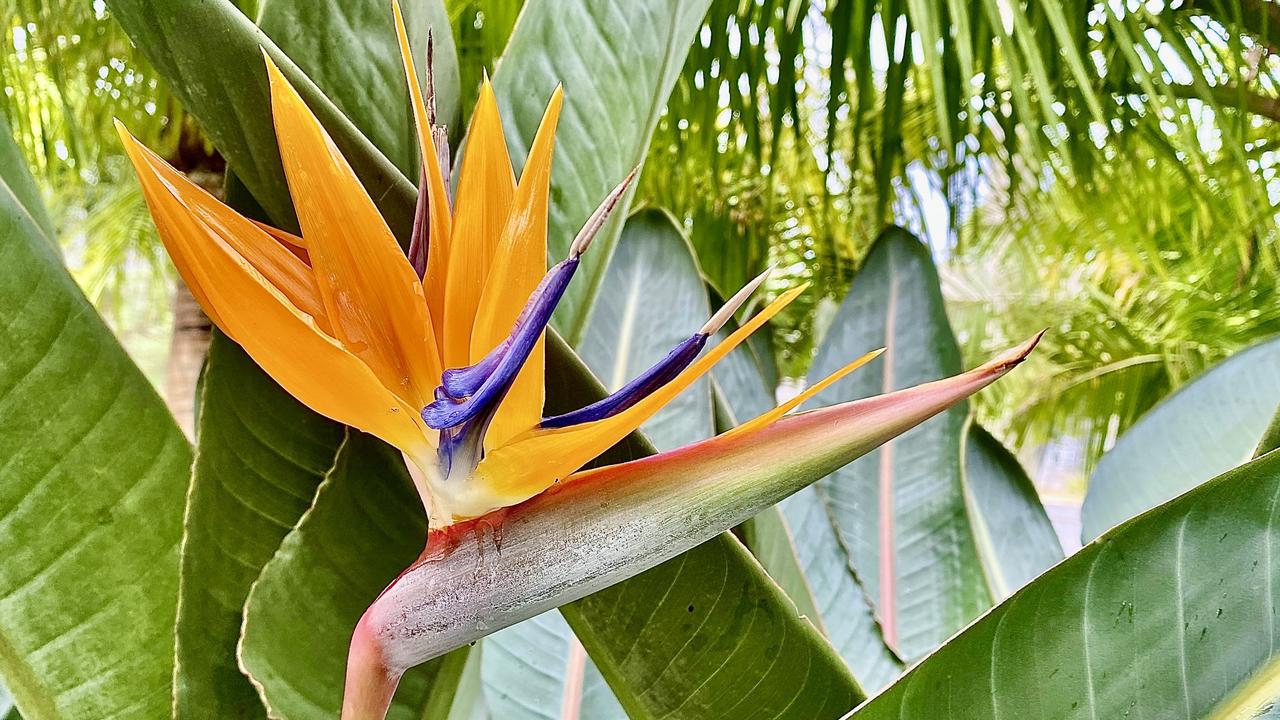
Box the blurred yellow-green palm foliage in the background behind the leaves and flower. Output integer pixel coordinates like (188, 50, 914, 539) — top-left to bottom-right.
(0, 0, 1280, 489)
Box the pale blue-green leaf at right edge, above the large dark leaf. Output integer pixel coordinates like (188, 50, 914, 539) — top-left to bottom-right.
(1080, 340, 1280, 541)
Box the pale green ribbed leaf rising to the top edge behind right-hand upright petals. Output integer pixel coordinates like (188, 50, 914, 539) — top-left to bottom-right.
(493, 0, 710, 345)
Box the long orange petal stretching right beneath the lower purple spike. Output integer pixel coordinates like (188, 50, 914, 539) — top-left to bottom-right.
(476, 283, 808, 505)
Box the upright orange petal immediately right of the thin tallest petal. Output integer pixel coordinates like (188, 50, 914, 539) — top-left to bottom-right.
(444, 78, 517, 368)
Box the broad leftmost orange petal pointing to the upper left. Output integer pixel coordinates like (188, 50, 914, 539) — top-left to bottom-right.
(122, 119, 424, 457)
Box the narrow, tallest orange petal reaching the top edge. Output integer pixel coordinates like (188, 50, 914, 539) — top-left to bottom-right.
(392, 0, 453, 345)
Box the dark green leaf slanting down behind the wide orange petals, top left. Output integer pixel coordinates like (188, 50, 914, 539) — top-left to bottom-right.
(108, 0, 417, 233)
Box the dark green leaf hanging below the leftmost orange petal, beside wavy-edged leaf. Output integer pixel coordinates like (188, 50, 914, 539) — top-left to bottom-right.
(174, 333, 344, 717)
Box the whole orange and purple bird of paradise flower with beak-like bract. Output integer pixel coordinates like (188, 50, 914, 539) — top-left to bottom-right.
(118, 6, 1038, 717)
